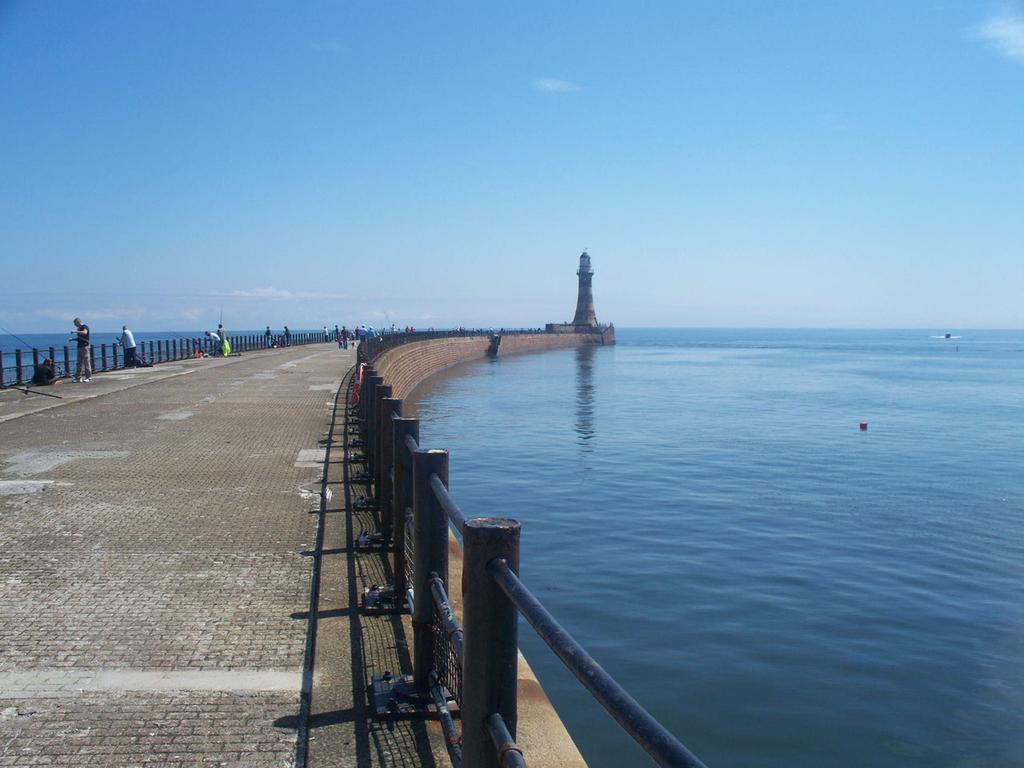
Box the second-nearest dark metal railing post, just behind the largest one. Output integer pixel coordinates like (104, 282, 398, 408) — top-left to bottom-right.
(413, 450, 450, 696)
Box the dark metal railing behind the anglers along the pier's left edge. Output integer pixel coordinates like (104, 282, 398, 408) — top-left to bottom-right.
(0, 332, 334, 388)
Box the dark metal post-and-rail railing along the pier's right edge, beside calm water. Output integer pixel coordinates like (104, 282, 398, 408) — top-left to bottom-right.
(350, 360, 703, 768)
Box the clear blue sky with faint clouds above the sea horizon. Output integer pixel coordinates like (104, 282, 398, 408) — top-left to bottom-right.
(0, 0, 1024, 332)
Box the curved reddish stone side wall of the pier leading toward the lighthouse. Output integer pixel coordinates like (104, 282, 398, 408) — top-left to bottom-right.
(373, 333, 607, 398)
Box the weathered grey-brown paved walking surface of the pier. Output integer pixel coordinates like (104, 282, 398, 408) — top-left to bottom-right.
(0, 344, 583, 768)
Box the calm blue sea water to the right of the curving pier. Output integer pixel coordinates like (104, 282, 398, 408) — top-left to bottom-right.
(407, 330, 1024, 768)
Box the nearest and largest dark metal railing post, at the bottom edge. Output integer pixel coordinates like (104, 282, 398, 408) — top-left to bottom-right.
(462, 517, 519, 768)
